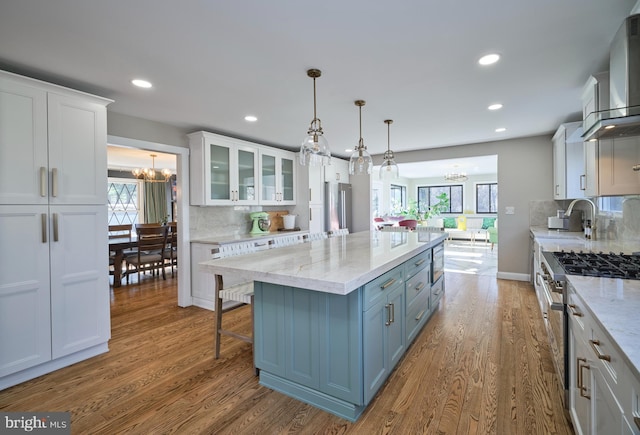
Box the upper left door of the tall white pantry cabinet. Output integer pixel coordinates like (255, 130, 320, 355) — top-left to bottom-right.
(0, 76, 49, 204)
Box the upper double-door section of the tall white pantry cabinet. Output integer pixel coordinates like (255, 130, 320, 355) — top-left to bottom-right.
(0, 73, 107, 205)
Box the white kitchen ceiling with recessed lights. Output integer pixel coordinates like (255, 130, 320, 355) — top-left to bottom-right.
(0, 0, 636, 162)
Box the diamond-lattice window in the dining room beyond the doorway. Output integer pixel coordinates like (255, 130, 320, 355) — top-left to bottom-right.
(107, 178, 142, 225)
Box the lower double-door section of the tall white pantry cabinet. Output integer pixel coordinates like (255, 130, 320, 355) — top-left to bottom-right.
(0, 205, 110, 380)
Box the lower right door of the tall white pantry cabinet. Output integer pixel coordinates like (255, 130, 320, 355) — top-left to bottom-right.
(50, 206, 110, 358)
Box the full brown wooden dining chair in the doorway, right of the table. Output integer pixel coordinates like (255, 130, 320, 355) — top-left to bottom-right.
(126, 225, 168, 283)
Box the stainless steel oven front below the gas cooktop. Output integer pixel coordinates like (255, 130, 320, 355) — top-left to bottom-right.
(536, 252, 569, 407)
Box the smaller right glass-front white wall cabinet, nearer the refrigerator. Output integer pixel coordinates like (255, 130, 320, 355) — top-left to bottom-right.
(260, 149, 296, 205)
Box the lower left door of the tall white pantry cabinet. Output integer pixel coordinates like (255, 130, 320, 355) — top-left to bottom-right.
(0, 205, 51, 377)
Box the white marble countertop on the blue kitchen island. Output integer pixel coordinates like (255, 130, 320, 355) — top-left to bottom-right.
(200, 231, 446, 295)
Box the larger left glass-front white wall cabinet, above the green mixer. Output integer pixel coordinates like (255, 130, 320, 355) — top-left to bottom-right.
(189, 132, 259, 205)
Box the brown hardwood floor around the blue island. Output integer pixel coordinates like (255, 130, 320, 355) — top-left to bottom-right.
(0, 273, 572, 434)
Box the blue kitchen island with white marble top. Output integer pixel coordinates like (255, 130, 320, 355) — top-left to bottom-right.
(200, 231, 446, 421)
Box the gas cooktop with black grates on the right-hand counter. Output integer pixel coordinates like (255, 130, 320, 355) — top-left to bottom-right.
(553, 251, 640, 279)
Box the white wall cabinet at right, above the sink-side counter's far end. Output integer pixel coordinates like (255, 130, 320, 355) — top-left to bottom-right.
(552, 122, 584, 199)
